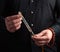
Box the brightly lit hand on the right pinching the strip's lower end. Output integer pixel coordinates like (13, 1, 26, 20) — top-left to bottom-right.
(32, 29, 52, 46)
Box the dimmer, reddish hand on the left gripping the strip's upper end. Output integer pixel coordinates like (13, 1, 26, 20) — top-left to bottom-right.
(5, 12, 22, 32)
